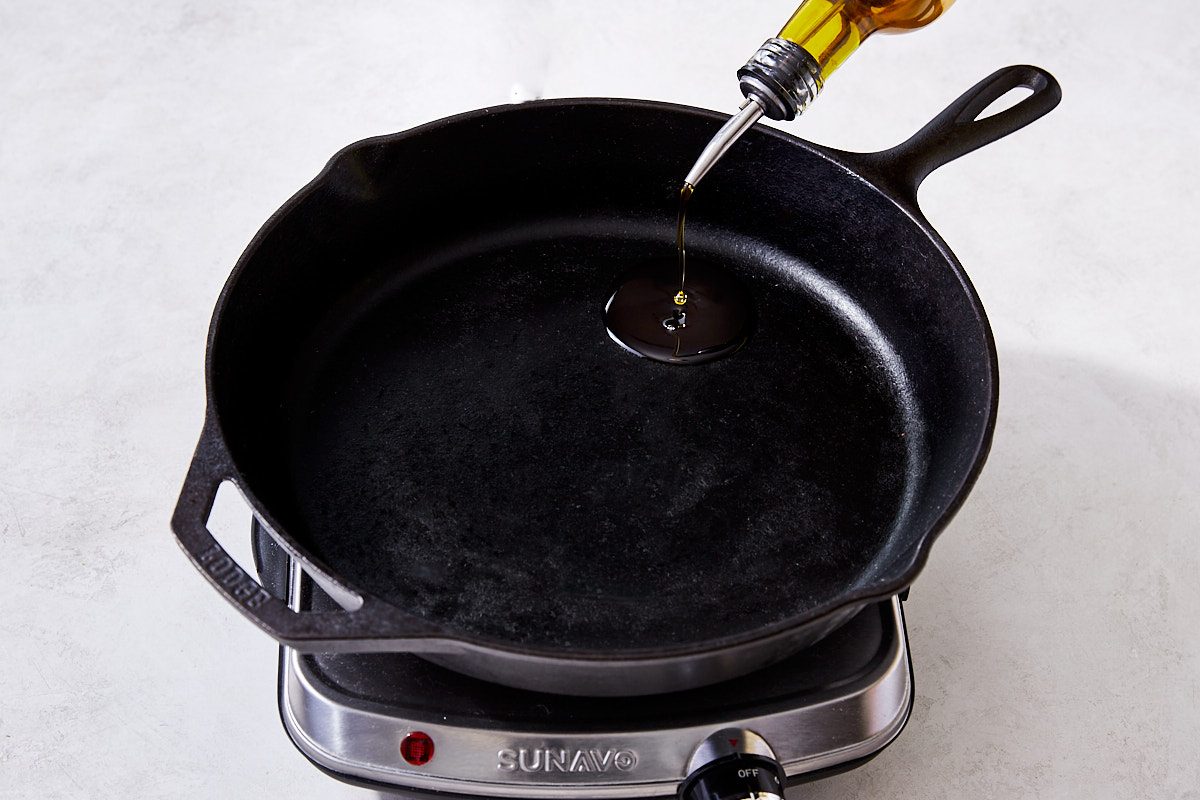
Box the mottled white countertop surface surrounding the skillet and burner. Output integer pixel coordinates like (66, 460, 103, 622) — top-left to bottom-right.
(0, 0, 1200, 799)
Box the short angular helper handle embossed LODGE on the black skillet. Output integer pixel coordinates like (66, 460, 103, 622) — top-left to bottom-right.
(170, 421, 446, 652)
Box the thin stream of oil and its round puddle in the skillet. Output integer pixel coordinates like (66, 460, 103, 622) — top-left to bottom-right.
(605, 184, 751, 363)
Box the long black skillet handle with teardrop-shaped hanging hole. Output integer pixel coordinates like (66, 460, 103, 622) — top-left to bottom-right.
(866, 65, 1062, 200)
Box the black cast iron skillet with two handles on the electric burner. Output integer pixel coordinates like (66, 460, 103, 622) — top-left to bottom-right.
(172, 66, 1061, 694)
